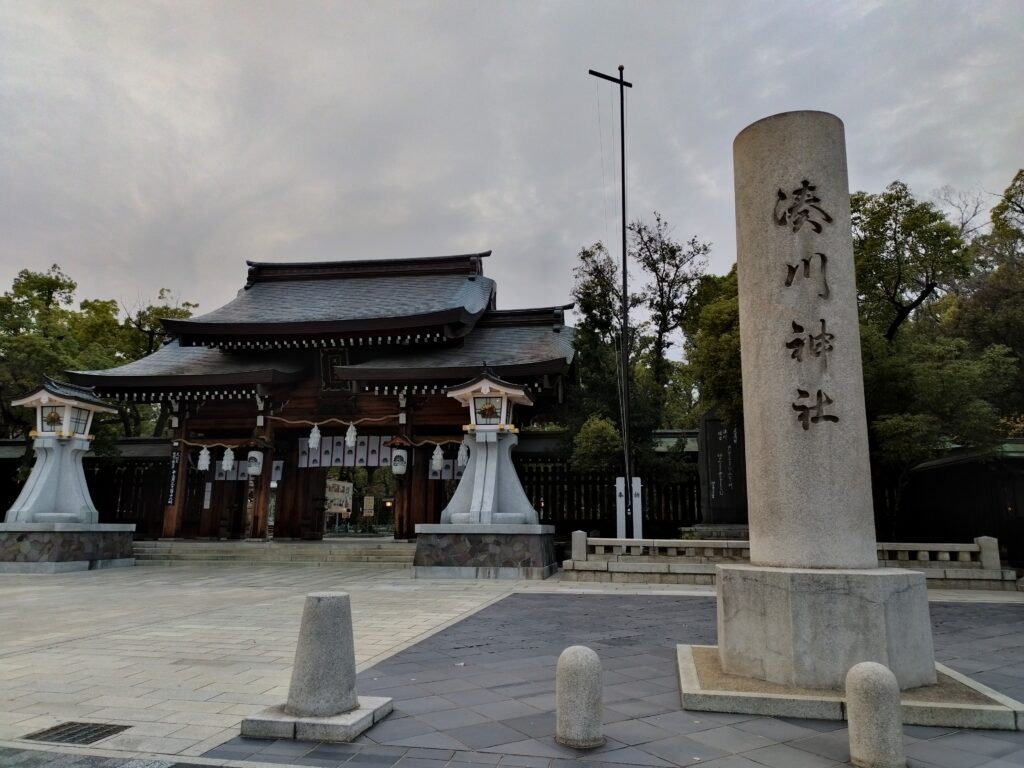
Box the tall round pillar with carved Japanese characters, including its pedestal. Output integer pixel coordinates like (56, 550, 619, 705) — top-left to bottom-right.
(718, 112, 936, 688)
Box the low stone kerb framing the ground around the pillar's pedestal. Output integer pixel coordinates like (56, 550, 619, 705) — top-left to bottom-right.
(676, 645, 1024, 731)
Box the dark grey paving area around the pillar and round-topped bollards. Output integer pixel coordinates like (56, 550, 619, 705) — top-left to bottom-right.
(205, 593, 1024, 768)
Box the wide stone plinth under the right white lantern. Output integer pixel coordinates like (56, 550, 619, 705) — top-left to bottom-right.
(413, 523, 558, 579)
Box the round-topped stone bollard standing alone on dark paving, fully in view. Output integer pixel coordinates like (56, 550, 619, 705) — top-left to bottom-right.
(555, 645, 604, 750)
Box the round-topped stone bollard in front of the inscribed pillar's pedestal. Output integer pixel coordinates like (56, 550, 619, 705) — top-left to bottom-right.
(846, 662, 906, 768)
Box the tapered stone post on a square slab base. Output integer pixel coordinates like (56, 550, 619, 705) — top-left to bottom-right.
(242, 592, 391, 741)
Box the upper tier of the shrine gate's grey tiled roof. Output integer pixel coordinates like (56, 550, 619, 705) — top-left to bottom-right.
(163, 252, 495, 345)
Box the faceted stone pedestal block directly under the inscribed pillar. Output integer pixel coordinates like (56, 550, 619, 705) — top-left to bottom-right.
(717, 565, 936, 689)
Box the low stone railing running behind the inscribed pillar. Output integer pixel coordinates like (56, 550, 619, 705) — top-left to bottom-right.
(562, 530, 1017, 590)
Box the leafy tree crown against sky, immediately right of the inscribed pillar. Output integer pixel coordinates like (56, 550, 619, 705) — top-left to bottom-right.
(850, 181, 971, 341)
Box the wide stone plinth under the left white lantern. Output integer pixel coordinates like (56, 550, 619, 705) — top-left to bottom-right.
(0, 522, 135, 573)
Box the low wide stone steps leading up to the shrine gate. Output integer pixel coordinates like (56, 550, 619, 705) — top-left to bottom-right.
(134, 539, 416, 568)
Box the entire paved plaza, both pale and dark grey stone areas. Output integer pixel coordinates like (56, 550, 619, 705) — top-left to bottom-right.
(0, 565, 1024, 768)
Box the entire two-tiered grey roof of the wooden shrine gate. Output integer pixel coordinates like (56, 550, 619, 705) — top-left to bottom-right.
(68, 260, 575, 399)
